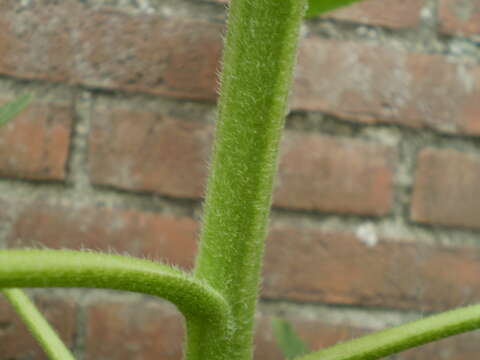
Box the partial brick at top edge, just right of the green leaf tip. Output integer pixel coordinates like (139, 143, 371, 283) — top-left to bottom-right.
(213, 0, 425, 29)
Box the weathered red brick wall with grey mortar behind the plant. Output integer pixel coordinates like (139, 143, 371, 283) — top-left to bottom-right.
(0, 0, 480, 360)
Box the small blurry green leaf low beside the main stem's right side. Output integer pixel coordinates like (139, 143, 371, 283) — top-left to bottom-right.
(272, 318, 310, 360)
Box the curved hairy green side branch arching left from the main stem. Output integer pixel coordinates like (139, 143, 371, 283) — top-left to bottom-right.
(0, 250, 232, 350)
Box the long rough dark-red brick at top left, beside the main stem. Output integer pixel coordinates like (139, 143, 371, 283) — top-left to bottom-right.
(0, 0, 223, 100)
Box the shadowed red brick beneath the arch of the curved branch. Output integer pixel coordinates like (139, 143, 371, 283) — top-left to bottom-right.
(85, 301, 184, 360)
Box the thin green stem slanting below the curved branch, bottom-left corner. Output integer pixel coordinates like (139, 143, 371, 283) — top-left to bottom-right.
(2, 289, 75, 360)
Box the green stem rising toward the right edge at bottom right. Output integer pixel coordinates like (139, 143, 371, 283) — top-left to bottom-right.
(296, 305, 480, 360)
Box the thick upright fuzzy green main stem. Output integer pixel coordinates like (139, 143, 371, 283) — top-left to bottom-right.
(191, 0, 306, 360)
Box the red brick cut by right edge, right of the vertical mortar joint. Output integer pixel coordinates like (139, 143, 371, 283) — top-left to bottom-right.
(411, 148, 480, 229)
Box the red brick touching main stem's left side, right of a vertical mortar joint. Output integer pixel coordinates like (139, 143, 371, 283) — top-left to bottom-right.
(90, 108, 213, 198)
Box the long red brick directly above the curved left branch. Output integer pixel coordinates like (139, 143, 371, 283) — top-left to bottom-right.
(7, 202, 197, 267)
